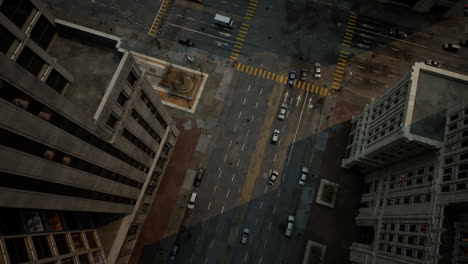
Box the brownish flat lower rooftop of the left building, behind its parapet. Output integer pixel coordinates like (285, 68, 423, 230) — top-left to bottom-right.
(49, 26, 123, 115)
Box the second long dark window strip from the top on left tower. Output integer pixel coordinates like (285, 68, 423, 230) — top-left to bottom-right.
(0, 128, 142, 189)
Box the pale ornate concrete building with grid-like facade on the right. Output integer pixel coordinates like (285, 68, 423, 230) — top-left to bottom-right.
(342, 63, 468, 264)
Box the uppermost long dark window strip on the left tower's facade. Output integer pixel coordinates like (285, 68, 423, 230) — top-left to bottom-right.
(0, 79, 149, 173)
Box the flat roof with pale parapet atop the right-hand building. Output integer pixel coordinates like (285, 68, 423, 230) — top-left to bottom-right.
(408, 63, 468, 141)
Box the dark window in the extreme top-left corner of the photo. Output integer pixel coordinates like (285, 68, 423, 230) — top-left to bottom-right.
(0, 0, 34, 28)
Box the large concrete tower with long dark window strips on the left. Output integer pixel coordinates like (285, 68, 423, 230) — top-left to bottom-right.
(0, 0, 178, 264)
